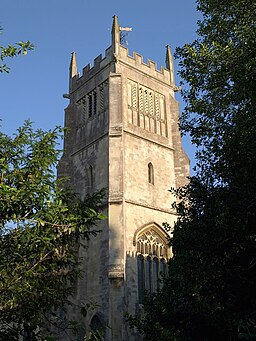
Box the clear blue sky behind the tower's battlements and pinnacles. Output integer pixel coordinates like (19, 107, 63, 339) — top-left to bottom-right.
(0, 0, 200, 170)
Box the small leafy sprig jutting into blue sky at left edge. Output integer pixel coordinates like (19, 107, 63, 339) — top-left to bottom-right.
(0, 27, 34, 73)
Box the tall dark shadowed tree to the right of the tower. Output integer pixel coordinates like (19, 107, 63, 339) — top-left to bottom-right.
(130, 0, 256, 340)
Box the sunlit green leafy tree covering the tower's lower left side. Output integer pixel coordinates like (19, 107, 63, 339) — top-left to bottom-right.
(0, 122, 104, 340)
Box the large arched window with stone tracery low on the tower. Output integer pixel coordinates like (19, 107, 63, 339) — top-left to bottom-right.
(134, 224, 169, 303)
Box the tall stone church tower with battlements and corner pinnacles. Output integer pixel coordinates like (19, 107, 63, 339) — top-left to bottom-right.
(58, 16, 189, 341)
